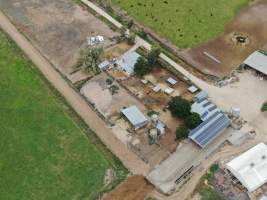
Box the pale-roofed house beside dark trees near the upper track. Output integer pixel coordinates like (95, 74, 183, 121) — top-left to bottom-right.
(116, 52, 141, 75)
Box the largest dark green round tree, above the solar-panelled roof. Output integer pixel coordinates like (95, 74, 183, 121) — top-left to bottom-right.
(169, 96, 191, 118)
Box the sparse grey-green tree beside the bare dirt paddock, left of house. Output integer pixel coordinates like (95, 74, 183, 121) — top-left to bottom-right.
(83, 48, 104, 72)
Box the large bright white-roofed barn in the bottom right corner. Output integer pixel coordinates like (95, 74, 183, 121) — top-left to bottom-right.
(226, 143, 267, 192)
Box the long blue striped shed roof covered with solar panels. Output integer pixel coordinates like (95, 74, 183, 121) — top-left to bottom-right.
(189, 111, 231, 148)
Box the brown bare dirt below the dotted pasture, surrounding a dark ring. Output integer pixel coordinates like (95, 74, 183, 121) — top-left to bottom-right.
(181, 0, 267, 77)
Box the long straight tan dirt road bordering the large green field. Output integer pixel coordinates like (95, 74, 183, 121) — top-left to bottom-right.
(0, 11, 149, 175)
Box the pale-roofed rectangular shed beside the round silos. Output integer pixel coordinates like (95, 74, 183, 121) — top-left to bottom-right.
(121, 106, 148, 130)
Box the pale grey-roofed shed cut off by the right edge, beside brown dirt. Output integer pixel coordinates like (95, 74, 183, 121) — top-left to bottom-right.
(244, 51, 267, 75)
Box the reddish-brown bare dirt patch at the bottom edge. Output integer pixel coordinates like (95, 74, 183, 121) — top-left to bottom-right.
(102, 176, 153, 200)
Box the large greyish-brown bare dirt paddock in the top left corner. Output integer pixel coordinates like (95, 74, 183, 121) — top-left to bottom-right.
(0, 0, 119, 75)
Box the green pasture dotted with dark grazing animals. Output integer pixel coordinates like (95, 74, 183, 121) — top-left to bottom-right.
(111, 0, 249, 48)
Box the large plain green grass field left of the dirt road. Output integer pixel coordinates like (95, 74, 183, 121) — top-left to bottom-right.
(0, 30, 127, 200)
